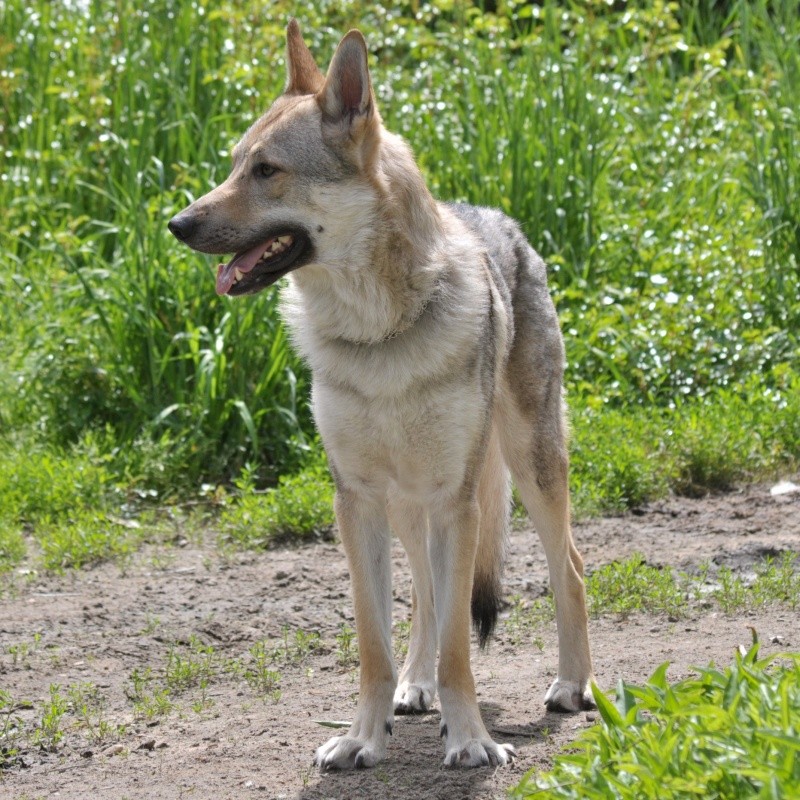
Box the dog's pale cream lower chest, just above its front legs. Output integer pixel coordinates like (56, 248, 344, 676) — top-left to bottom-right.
(313, 382, 489, 502)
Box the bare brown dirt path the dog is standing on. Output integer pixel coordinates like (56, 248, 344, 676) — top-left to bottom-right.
(0, 487, 800, 800)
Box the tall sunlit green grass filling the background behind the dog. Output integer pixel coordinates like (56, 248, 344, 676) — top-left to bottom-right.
(0, 0, 800, 489)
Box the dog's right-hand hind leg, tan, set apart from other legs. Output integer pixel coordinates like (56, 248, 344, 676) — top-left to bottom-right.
(502, 390, 594, 711)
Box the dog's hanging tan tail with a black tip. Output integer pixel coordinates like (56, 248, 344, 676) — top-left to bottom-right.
(472, 430, 511, 648)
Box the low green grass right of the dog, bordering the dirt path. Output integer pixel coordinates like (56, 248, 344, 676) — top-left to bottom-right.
(571, 377, 800, 516)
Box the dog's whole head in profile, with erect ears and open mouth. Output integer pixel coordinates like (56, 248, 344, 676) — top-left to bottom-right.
(169, 20, 382, 295)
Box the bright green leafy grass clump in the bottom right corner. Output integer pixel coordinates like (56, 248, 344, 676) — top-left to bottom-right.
(511, 644, 800, 800)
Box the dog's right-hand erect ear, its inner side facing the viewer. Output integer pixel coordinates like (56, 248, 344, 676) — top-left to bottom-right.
(317, 30, 375, 128)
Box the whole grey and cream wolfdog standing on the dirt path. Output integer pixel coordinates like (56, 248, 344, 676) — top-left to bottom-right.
(169, 20, 593, 770)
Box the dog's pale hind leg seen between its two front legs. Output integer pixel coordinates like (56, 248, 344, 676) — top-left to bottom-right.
(388, 493, 436, 714)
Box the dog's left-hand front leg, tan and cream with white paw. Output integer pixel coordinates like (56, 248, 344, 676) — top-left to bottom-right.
(315, 489, 397, 770)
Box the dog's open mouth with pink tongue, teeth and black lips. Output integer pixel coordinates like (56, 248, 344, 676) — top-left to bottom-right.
(217, 231, 310, 295)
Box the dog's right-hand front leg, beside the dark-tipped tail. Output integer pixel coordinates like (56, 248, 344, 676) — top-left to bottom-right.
(430, 498, 514, 767)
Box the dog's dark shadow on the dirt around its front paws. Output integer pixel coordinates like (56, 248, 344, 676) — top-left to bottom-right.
(297, 703, 567, 800)
